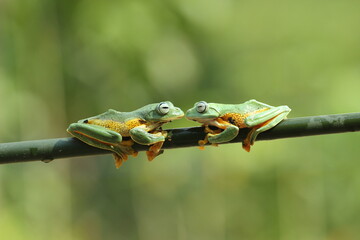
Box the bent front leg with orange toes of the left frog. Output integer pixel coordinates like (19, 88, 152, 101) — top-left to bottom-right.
(130, 126, 167, 161)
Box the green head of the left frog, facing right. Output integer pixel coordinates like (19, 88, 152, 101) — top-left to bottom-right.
(144, 101, 184, 123)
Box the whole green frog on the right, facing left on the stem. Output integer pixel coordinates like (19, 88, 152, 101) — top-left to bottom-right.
(186, 99, 291, 152)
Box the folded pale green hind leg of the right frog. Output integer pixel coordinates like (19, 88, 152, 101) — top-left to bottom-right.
(243, 106, 291, 152)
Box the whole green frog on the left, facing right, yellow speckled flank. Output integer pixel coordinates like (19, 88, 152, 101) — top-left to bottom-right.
(67, 101, 184, 168)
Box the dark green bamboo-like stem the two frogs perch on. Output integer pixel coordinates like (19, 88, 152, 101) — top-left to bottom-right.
(0, 113, 360, 164)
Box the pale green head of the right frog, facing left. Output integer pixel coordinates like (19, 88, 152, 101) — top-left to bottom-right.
(186, 101, 220, 123)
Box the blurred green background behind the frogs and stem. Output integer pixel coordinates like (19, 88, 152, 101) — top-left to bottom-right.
(0, 0, 360, 240)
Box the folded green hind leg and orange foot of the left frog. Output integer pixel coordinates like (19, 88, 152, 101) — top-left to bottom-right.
(67, 123, 137, 168)
